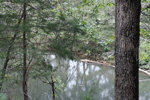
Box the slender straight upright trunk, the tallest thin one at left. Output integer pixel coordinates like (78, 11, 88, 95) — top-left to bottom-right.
(22, 3, 28, 100)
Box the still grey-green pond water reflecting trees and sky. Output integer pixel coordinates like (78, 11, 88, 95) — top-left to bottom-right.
(3, 54, 150, 100)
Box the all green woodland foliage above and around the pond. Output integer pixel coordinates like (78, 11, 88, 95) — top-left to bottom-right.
(0, 0, 150, 100)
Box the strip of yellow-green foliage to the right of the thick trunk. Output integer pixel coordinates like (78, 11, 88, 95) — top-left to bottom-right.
(139, 0, 150, 69)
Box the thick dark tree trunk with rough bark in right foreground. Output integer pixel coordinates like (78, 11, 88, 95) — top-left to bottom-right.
(115, 0, 141, 100)
